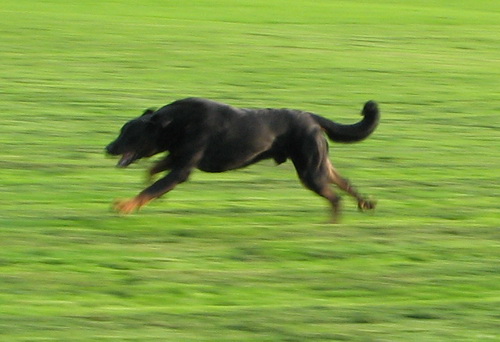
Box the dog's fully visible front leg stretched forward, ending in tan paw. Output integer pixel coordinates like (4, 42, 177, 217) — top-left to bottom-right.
(114, 168, 192, 214)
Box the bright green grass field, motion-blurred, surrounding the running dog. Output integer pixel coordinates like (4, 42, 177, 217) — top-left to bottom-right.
(0, 0, 500, 342)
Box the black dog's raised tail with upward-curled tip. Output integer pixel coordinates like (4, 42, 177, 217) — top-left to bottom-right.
(311, 101, 380, 143)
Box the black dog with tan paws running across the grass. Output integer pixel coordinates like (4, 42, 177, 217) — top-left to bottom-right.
(106, 98, 380, 221)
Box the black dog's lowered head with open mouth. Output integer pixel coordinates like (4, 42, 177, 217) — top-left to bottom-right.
(106, 109, 168, 167)
